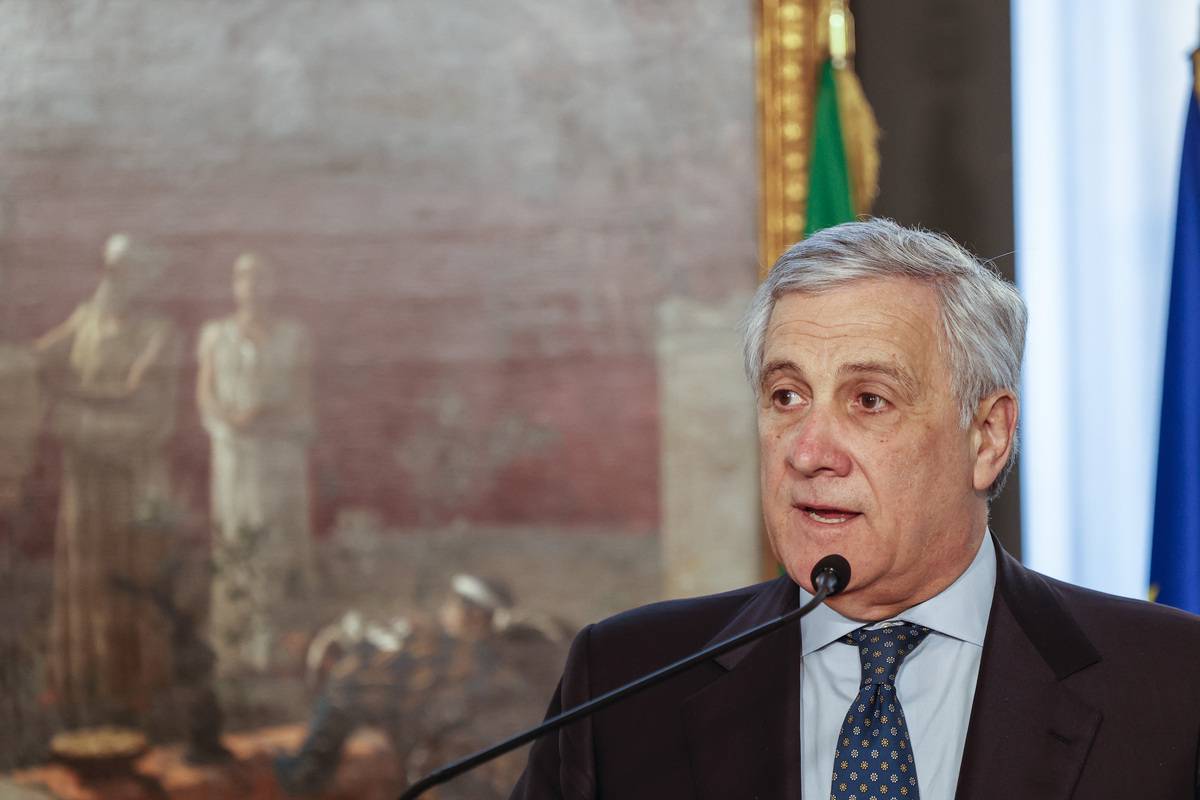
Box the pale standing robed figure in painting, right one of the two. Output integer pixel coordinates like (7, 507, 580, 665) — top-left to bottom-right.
(197, 253, 313, 675)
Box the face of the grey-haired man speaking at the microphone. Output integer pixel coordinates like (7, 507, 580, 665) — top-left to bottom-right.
(758, 278, 986, 620)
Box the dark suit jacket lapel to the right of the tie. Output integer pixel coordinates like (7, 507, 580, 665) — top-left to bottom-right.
(956, 545, 1100, 800)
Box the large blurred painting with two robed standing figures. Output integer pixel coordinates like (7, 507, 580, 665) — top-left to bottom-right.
(0, 0, 758, 800)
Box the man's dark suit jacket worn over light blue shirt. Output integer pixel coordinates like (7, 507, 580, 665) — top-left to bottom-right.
(512, 545, 1200, 800)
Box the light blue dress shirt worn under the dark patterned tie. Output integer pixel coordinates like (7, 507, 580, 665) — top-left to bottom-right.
(800, 534, 996, 800)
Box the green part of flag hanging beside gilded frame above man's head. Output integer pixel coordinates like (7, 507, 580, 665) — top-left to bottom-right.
(804, 60, 854, 236)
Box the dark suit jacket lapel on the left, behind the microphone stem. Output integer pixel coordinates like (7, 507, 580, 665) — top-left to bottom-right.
(683, 578, 800, 800)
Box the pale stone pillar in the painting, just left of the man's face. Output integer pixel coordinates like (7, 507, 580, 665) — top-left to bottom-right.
(656, 295, 761, 597)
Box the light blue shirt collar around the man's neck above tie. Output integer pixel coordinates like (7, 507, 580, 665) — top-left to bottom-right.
(800, 531, 996, 656)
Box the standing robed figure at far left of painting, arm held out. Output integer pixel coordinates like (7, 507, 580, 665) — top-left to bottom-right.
(34, 234, 179, 724)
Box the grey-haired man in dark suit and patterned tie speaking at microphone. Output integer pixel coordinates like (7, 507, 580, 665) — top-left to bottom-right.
(514, 219, 1200, 800)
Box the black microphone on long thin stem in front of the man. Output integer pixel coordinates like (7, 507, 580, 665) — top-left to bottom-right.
(400, 554, 850, 800)
